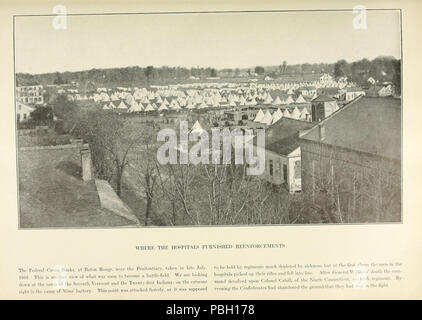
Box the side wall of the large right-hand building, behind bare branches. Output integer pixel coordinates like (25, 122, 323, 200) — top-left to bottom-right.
(300, 139, 401, 222)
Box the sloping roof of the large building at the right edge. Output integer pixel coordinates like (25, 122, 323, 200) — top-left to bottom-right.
(301, 97, 401, 160)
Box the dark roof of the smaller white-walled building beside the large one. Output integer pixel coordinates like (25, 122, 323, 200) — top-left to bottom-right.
(265, 117, 313, 155)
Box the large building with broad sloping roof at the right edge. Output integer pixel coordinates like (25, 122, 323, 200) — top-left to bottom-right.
(300, 97, 401, 222)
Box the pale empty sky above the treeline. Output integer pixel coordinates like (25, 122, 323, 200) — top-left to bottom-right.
(15, 10, 401, 74)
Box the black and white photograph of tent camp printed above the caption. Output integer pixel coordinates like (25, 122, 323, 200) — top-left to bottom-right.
(14, 5, 404, 229)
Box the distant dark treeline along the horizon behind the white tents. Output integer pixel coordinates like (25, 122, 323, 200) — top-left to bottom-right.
(16, 57, 401, 89)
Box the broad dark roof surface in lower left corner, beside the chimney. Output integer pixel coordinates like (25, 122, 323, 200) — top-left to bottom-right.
(18, 149, 132, 228)
